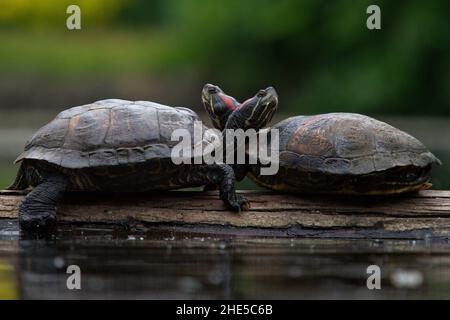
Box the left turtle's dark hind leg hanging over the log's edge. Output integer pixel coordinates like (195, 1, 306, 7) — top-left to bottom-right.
(19, 173, 67, 231)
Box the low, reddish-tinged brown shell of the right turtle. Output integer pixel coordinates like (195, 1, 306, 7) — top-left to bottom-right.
(273, 113, 440, 175)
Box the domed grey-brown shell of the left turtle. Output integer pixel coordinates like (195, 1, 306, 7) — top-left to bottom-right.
(16, 99, 200, 169)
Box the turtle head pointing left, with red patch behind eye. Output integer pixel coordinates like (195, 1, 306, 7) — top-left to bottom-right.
(202, 83, 240, 130)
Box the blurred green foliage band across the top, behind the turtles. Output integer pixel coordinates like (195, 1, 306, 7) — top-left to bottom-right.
(0, 0, 450, 115)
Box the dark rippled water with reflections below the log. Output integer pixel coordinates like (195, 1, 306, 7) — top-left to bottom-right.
(0, 223, 450, 299)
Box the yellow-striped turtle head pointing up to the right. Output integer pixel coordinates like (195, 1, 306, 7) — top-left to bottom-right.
(225, 87, 278, 130)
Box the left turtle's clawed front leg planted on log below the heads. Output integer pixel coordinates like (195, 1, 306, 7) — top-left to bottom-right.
(194, 164, 250, 211)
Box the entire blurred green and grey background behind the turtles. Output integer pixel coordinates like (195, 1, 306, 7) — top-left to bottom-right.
(0, 0, 450, 188)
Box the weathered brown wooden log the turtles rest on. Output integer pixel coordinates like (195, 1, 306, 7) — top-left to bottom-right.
(0, 190, 450, 238)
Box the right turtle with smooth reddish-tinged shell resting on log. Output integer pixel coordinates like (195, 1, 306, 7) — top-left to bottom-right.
(205, 89, 441, 195)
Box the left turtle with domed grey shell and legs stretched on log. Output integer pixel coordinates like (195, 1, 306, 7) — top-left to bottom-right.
(8, 85, 274, 231)
